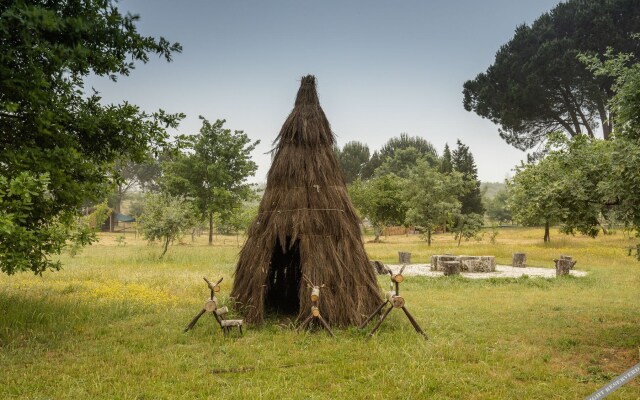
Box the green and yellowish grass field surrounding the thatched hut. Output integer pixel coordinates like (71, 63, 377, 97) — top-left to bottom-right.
(0, 228, 640, 399)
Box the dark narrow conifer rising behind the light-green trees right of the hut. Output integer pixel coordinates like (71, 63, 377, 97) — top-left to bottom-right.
(451, 140, 484, 215)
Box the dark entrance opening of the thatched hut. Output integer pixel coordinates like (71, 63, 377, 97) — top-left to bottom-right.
(266, 237, 302, 315)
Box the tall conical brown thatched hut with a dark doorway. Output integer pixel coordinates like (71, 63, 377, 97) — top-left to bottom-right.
(231, 75, 381, 325)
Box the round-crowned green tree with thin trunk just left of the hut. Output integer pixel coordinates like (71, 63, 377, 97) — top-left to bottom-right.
(162, 116, 260, 245)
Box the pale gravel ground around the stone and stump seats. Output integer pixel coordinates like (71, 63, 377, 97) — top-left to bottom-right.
(385, 264, 587, 279)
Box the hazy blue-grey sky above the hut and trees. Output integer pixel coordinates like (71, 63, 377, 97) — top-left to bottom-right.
(87, 0, 559, 182)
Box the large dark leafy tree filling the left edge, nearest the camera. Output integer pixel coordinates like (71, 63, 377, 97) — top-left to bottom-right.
(0, 0, 181, 274)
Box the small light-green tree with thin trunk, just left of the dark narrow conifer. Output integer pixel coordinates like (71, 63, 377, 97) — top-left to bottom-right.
(404, 160, 465, 246)
